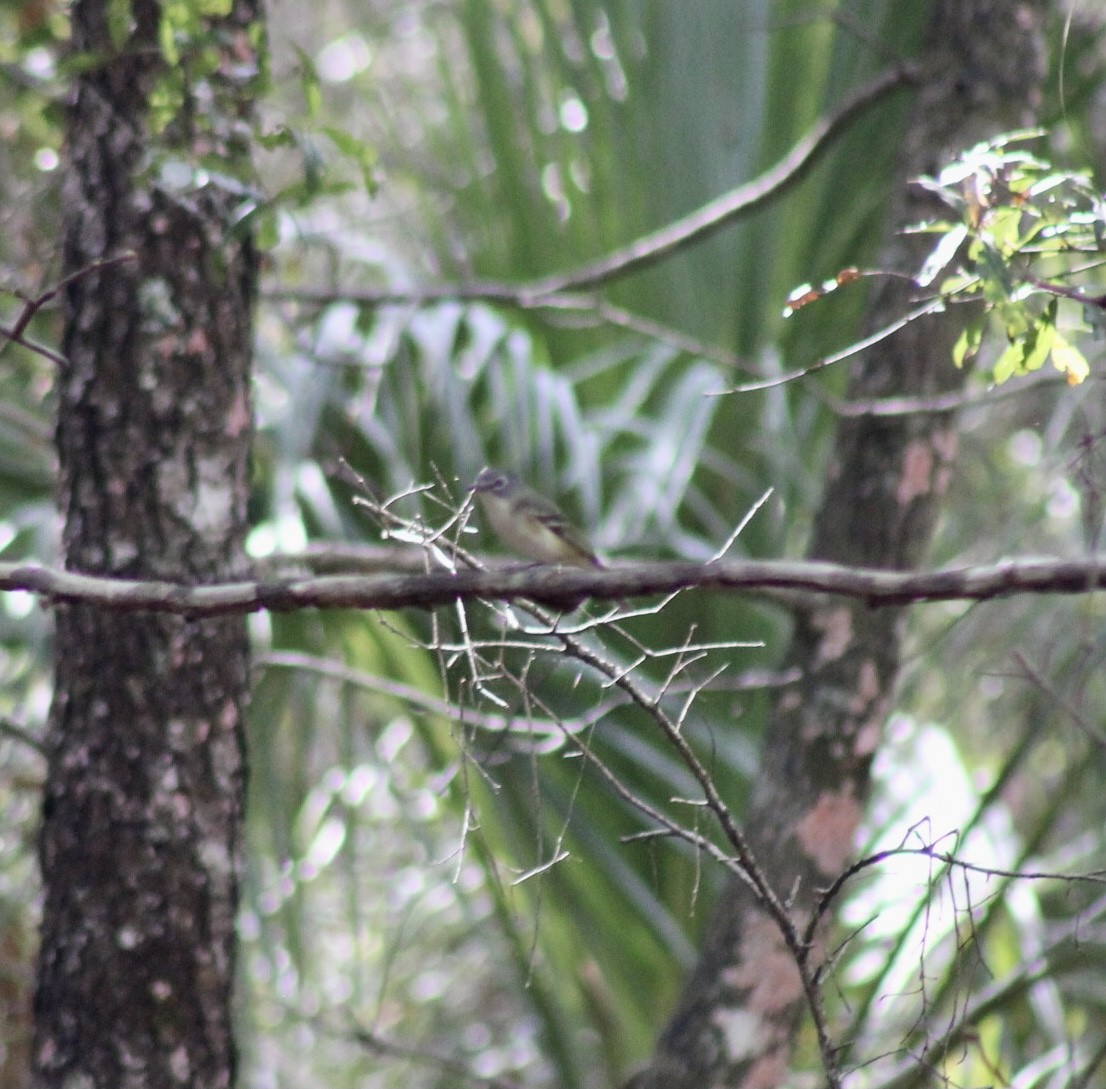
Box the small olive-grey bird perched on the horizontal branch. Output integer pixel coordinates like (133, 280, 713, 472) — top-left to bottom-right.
(471, 469, 603, 567)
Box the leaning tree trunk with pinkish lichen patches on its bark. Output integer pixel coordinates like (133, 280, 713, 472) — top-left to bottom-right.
(634, 0, 1046, 1089)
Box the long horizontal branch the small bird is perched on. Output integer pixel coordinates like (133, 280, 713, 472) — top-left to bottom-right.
(0, 557, 1106, 617)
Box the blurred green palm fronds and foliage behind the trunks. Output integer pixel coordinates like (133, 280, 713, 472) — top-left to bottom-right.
(0, 0, 1106, 1087)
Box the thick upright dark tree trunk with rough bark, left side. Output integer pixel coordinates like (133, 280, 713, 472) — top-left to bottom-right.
(33, 0, 259, 1089)
